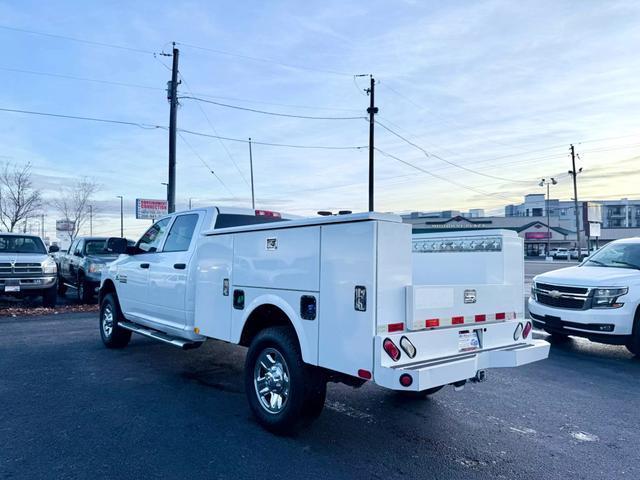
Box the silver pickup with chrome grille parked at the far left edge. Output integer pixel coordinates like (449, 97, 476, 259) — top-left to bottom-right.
(0, 233, 58, 307)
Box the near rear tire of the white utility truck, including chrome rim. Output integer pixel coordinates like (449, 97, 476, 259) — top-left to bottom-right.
(244, 327, 327, 435)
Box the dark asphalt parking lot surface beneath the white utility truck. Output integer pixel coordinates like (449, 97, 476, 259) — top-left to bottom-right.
(0, 313, 640, 479)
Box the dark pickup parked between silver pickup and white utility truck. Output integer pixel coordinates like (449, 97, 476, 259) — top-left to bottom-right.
(56, 237, 125, 303)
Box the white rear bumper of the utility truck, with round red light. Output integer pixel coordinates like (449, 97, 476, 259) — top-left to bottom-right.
(374, 340, 549, 391)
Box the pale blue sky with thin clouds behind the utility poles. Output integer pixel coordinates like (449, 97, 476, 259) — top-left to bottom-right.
(0, 0, 640, 238)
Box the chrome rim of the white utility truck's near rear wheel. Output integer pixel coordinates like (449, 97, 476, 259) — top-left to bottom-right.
(253, 348, 290, 414)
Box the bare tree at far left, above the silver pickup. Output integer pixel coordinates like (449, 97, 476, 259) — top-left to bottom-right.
(0, 163, 42, 232)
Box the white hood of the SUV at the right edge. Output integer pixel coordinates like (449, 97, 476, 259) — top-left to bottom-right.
(533, 267, 640, 287)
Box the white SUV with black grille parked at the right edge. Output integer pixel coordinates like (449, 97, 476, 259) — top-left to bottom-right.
(529, 238, 640, 356)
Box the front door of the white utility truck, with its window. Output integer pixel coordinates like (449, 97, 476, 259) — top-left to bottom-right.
(116, 217, 171, 319)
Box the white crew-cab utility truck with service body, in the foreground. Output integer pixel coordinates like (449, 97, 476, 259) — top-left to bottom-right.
(100, 207, 549, 432)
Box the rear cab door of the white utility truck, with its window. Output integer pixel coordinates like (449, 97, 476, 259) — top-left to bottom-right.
(147, 212, 202, 330)
